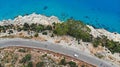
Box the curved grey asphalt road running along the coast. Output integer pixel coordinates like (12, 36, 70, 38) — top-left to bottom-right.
(0, 38, 119, 67)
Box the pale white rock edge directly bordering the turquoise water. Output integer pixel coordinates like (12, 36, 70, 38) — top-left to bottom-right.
(0, 13, 120, 42)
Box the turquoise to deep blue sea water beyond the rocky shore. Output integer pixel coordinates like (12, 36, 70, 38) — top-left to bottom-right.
(0, 0, 120, 33)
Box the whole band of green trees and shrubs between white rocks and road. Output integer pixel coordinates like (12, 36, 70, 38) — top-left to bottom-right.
(0, 19, 120, 53)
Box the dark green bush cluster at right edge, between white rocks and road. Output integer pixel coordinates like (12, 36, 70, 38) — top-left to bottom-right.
(92, 36, 120, 53)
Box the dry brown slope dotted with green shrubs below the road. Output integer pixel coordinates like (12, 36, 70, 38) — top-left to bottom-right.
(0, 47, 93, 67)
